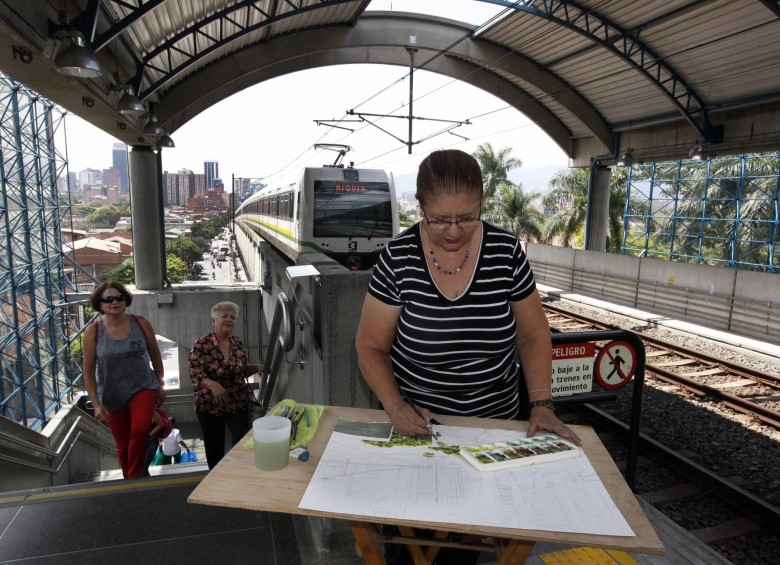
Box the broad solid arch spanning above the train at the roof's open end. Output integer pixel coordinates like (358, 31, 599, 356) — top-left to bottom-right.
(158, 14, 592, 156)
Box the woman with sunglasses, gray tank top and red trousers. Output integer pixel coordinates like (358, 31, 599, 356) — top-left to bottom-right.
(82, 281, 165, 479)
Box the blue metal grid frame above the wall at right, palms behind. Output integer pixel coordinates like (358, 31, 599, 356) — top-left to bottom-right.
(622, 152, 780, 273)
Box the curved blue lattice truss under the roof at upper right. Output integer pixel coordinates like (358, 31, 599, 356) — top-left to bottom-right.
(478, 0, 723, 141)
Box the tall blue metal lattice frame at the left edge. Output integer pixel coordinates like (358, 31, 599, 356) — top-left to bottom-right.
(0, 74, 81, 429)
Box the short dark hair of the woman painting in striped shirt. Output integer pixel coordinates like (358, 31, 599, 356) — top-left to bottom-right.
(415, 149, 482, 208)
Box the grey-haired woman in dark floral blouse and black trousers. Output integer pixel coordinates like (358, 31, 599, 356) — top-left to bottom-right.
(189, 302, 263, 469)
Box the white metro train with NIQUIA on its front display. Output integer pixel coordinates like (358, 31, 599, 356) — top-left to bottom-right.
(236, 166, 399, 271)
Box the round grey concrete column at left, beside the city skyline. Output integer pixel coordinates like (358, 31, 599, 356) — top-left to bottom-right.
(130, 145, 165, 290)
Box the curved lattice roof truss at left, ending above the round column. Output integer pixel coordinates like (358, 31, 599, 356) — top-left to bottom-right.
(132, 0, 354, 100)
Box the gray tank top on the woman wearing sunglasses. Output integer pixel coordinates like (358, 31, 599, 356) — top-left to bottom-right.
(95, 316, 160, 412)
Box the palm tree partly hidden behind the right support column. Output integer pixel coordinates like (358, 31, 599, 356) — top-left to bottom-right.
(542, 168, 626, 249)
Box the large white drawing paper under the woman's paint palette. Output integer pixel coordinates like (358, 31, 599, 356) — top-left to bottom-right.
(299, 426, 634, 536)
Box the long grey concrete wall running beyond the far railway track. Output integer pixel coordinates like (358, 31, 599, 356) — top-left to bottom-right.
(526, 243, 780, 343)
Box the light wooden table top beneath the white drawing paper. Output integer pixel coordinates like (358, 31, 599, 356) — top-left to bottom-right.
(187, 406, 664, 554)
